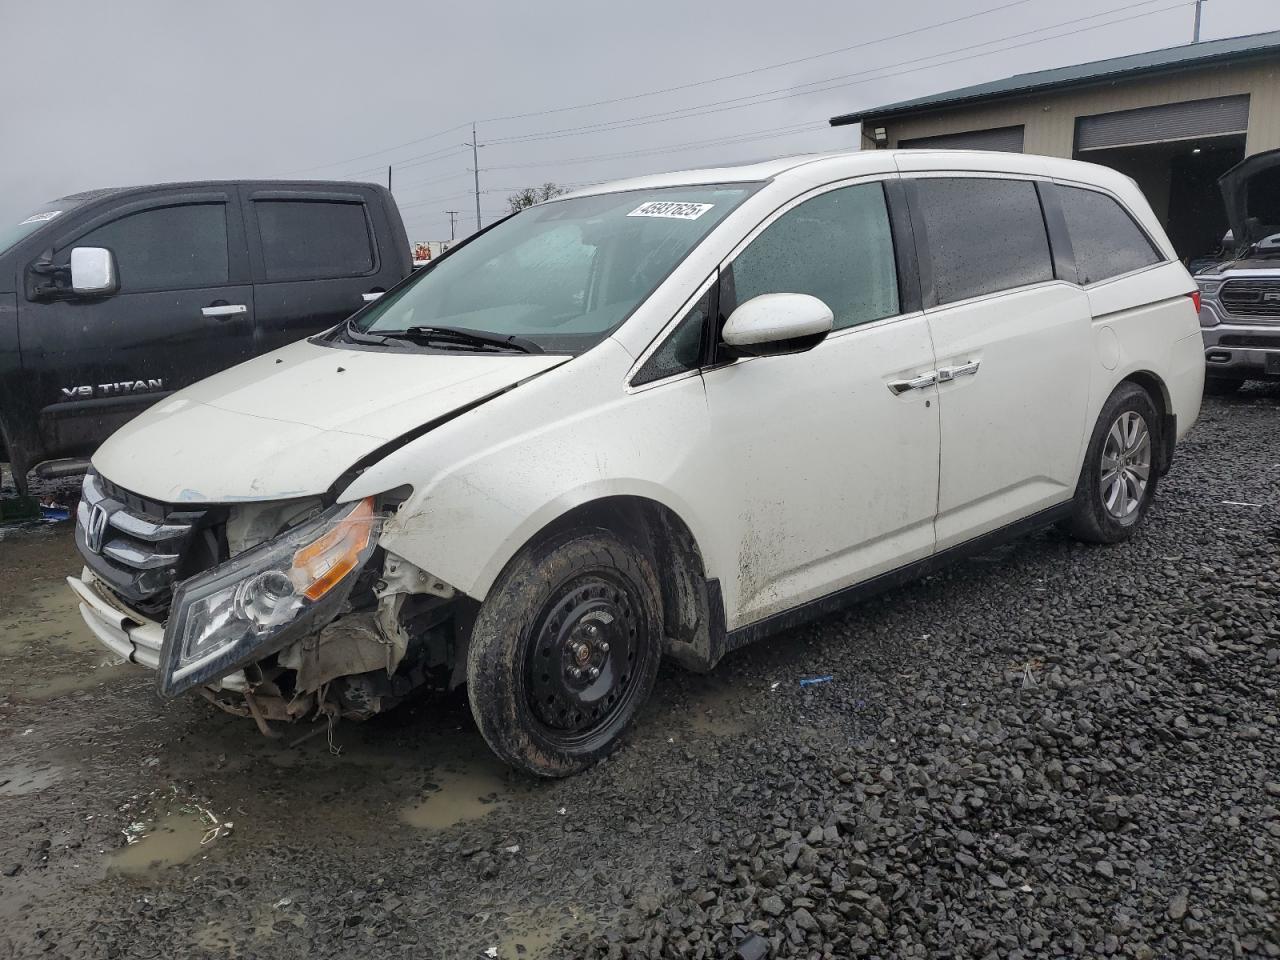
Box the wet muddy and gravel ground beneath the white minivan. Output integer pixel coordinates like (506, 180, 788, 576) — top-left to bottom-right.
(0, 387, 1280, 959)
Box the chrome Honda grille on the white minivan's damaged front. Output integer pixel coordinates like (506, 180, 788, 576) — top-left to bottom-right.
(76, 472, 223, 614)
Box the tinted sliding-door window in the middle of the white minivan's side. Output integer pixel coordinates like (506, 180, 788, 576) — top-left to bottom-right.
(914, 177, 1053, 303)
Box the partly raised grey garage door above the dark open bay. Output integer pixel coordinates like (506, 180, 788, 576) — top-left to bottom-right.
(1075, 93, 1249, 152)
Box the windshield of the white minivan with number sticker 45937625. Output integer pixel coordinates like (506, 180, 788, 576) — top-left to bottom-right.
(352, 183, 756, 353)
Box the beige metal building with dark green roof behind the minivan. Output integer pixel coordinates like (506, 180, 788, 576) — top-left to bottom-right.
(831, 31, 1280, 257)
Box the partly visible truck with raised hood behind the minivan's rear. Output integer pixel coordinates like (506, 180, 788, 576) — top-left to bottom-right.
(1194, 150, 1280, 393)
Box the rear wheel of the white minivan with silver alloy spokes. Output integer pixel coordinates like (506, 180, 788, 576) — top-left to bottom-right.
(1066, 383, 1161, 543)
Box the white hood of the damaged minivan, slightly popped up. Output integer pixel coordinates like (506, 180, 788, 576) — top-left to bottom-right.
(93, 342, 568, 503)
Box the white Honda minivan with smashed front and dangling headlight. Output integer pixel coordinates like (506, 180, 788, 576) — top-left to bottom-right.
(69, 151, 1204, 776)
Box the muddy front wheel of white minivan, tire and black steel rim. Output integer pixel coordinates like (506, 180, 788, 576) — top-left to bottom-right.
(467, 530, 662, 777)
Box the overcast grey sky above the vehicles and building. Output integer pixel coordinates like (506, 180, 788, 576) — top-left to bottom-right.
(0, 0, 1280, 239)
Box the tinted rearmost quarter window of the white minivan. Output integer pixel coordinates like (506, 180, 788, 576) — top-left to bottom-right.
(1057, 187, 1162, 283)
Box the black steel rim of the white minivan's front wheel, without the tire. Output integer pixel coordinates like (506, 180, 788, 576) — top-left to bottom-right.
(525, 573, 649, 748)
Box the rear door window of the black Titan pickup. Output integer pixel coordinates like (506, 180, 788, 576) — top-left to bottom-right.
(253, 200, 374, 280)
